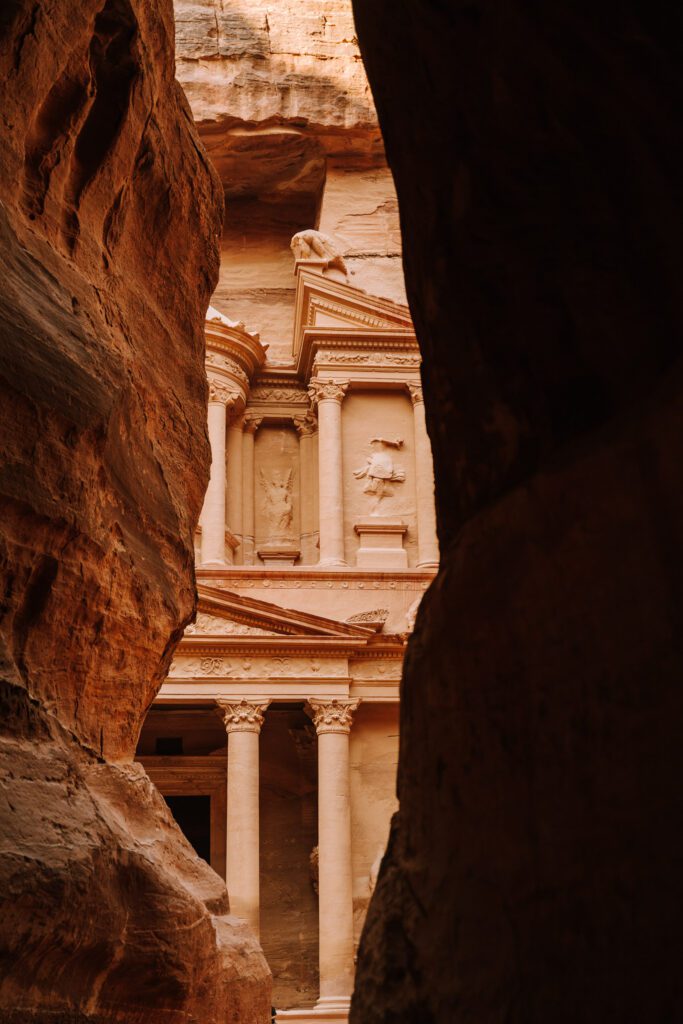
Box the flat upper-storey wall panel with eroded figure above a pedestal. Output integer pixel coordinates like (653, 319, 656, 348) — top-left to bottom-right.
(342, 390, 418, 568)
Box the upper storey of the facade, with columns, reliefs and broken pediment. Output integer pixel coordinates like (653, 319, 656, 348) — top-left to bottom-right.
(197, 230, 438, 570)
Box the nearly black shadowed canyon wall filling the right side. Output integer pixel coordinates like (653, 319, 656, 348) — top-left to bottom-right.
(351, 0, 683, 1024)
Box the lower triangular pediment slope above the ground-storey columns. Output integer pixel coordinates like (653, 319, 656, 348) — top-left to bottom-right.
(184, 584, 375, 640)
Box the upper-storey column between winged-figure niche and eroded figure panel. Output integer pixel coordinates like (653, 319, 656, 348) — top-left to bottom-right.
(308, 380, 348, 565)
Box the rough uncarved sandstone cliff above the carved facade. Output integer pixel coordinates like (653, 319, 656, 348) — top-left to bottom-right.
(175, 0, 404, 359)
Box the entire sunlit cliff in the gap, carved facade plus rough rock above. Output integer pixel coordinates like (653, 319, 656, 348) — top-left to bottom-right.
(137, 0, 438, 1024)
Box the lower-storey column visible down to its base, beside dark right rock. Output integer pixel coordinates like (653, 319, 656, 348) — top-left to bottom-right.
(307, 697, 359, 1011)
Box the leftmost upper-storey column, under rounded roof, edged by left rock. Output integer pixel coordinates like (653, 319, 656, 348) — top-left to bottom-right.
(200, 378, 240, 568)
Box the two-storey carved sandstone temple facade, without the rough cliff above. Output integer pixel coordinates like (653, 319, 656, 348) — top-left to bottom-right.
(138, 231, 438, 1022)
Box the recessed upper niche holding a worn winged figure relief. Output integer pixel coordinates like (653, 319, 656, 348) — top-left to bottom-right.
(254, 424, 301, 565)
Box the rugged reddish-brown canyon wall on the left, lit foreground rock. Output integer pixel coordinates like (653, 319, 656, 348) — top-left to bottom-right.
(0, 0, 269, 1024)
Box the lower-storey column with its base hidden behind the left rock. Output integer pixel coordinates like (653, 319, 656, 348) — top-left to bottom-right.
(216, 698, 270, 936)
